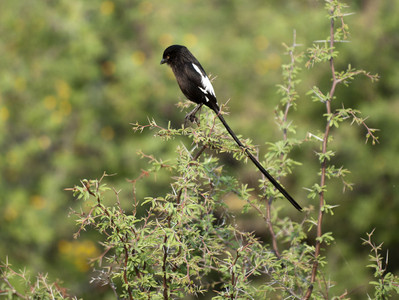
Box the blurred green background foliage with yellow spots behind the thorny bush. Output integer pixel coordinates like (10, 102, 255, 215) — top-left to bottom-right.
(0, 0, 399, 299)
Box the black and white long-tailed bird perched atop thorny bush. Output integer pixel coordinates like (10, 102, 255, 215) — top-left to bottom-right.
(161, 45, 302, 211)
